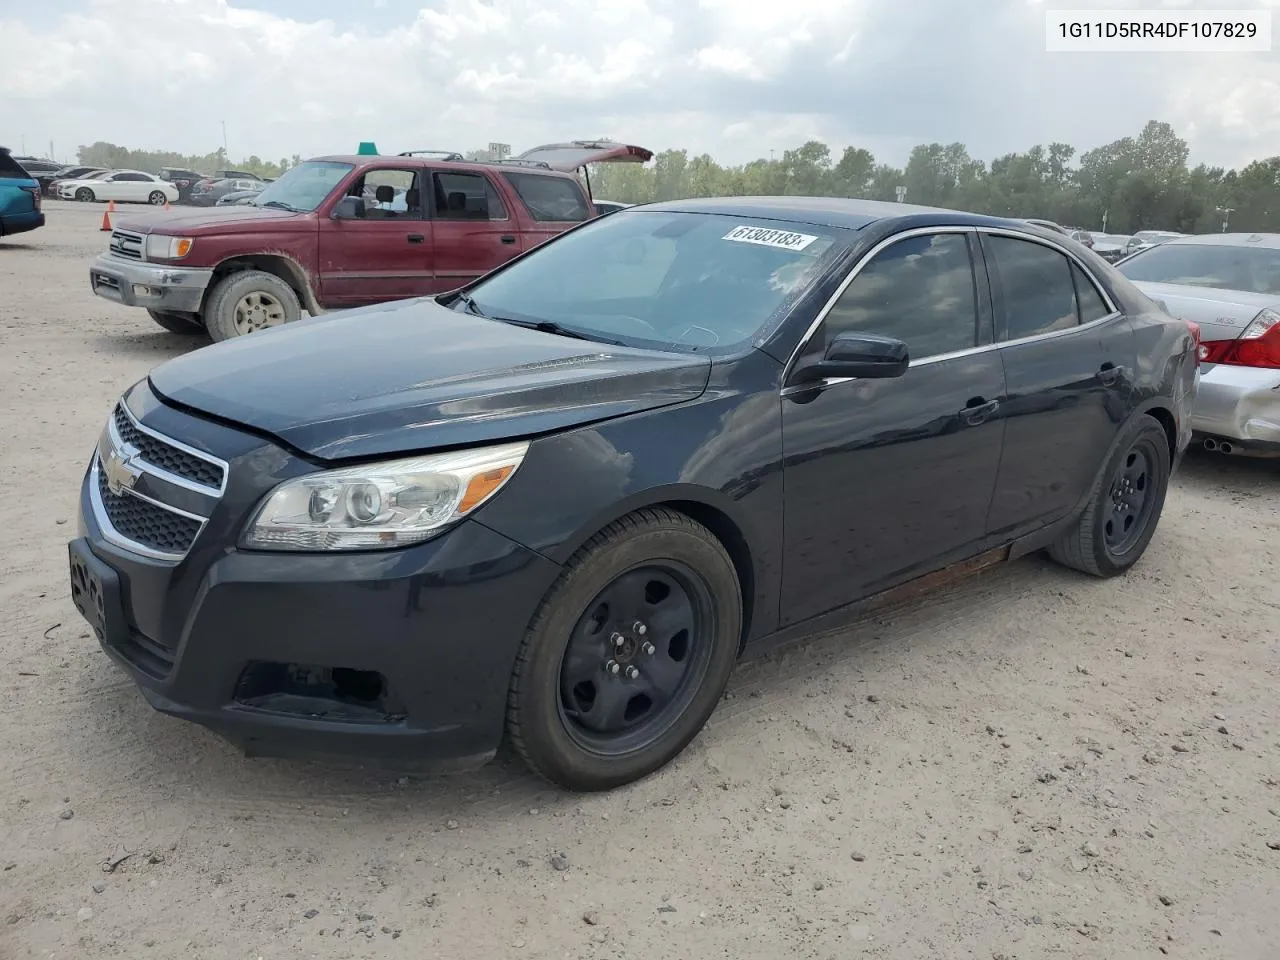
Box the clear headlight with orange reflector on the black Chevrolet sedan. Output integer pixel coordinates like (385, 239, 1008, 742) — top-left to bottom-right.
(243, 443, 529, 550)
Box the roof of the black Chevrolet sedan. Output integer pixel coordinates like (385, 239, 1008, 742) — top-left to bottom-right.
(635, 197, 1046, 230)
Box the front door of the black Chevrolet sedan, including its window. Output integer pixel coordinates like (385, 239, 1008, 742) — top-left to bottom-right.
(781, 229, 1005, 625)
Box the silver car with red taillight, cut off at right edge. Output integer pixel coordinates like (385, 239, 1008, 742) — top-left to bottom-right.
(1116, 233, 1280, 456)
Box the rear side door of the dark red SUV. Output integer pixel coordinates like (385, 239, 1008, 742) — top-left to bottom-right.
(431, 170, 521, 293)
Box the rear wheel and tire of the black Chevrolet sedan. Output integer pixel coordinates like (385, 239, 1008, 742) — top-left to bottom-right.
(1048, 413, 1170, 577)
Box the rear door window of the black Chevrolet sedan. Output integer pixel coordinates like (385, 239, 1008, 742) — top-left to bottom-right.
(983, 236, 1079, 340)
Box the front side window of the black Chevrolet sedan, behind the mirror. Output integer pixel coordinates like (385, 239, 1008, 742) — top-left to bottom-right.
(814, 233, 978, 360)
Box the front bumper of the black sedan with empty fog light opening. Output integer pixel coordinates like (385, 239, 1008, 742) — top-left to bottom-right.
(69, 389, 559, 765)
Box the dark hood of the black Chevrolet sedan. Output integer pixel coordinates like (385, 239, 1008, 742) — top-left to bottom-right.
(150, 302, 710, 461)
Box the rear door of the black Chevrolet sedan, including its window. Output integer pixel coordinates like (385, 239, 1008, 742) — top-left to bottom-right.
(980, 233, 1137, 538)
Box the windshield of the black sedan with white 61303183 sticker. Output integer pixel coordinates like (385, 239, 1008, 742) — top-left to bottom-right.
(458, 210, 846, 351)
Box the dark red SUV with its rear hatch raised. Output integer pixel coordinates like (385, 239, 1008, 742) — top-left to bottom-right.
(90, 141, 653, 340)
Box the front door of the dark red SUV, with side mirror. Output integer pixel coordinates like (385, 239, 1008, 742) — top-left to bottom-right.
(319, 168, 433, 307)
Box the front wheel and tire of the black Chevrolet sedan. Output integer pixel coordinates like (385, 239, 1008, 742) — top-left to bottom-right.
(507, 508, 742, 791)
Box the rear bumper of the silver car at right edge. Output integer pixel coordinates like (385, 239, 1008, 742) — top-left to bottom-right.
(1192, 364, 1280, 448)
